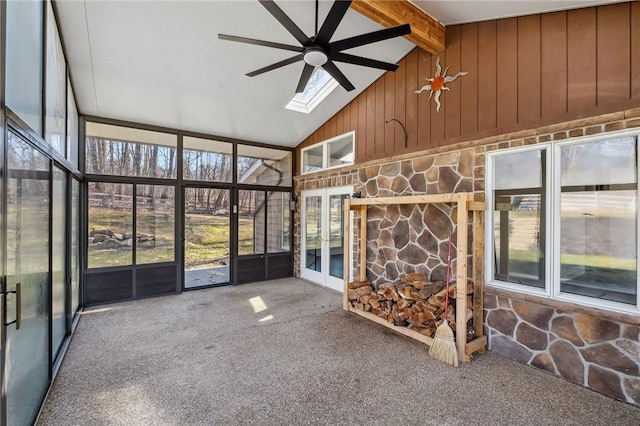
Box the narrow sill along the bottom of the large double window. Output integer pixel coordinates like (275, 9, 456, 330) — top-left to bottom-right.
(485, 286, 640, 325)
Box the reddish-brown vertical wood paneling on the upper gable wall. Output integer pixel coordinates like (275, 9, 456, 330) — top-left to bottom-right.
(298, 2, 640, 164)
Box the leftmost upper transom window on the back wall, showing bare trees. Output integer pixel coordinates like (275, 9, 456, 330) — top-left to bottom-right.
(86, 122, 178, 179)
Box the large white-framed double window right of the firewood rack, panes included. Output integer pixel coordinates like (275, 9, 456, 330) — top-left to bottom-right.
(487, 133, 640, 312)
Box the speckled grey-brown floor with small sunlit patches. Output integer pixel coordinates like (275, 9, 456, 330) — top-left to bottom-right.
(38, 278, 640, 426)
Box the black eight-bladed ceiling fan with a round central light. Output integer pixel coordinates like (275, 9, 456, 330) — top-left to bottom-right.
(218, 0, 411, 93)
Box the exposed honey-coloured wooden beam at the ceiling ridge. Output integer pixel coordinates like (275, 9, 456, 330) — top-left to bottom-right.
(351, 0, 445, 55)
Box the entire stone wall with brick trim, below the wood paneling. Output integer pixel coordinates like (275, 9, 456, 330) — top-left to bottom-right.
(294, 108, 640, 405)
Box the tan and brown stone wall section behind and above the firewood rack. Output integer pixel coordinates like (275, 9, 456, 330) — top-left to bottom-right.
(356, 149, 474, 288)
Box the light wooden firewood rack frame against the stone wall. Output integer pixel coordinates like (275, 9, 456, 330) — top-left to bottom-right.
(343, 192, 487, 362)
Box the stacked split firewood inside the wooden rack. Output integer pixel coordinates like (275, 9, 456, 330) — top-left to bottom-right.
(347, 274, 473, 337)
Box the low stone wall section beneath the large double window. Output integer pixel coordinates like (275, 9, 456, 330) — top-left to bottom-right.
(484, 288, 640, 405)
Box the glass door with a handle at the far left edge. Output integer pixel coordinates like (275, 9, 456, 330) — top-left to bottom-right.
(4, 131, 50, 425)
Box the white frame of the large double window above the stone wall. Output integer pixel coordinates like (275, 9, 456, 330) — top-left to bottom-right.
(485, 129, 640, 315)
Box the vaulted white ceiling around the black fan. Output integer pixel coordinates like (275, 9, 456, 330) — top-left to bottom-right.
(55, 0, 624, 147)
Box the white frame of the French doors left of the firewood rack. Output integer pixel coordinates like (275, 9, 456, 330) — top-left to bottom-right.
(299, 186, 353, 293)
